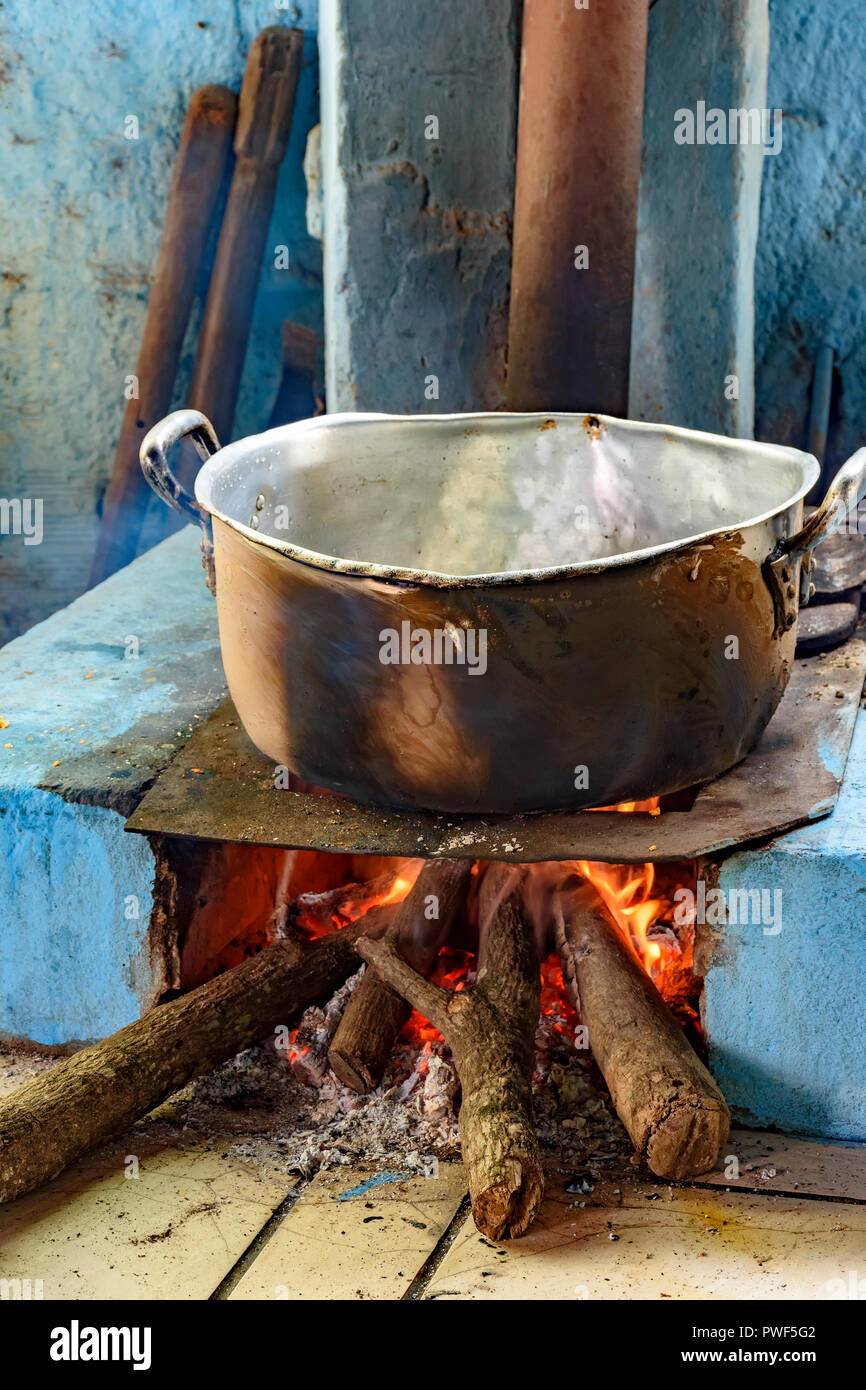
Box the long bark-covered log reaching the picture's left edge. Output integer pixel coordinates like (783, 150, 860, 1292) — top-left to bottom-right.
(0, 908, 393, 1201)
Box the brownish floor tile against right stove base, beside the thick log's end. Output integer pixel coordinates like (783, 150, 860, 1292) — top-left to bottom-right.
(698, 1129, 866, 1202)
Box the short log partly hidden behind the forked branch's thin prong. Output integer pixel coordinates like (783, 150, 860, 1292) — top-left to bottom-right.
(328, 859, 471, 1095)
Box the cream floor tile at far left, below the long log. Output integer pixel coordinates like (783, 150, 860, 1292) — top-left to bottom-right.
(0, 1136, 293, 1300)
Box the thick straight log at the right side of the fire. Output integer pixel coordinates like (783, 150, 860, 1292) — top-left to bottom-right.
(555, 884, 731, 1177)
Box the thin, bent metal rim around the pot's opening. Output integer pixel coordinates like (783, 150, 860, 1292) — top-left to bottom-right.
(195, 410, 822, 589)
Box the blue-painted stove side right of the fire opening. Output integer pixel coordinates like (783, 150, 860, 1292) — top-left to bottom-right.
(703, 712, 866, 1141)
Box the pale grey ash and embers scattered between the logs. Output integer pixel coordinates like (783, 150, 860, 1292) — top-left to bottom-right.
(155, 972, 631, 1176)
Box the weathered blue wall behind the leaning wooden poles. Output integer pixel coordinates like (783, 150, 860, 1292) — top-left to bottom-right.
(0, 0, 321, 642)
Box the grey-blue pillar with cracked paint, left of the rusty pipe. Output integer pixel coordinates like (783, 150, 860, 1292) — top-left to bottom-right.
(320, 0, 517, 413)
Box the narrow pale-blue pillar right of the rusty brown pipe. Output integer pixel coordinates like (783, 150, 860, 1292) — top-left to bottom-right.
(628, 0, 769, 438)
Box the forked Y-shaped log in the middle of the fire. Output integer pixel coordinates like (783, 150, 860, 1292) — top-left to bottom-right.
(357, 865, 544, 1240)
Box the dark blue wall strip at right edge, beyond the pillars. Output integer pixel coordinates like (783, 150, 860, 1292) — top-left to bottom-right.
(756, 0, 866, 463)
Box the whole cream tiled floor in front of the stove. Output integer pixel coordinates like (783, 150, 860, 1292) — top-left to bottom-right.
(0, 1130, 866, 1300)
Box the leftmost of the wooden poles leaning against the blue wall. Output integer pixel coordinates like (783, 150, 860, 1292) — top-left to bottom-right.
(90, 86, 238, 585)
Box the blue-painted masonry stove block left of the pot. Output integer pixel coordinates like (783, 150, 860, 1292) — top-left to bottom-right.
(0, 527, 225, 1044)
